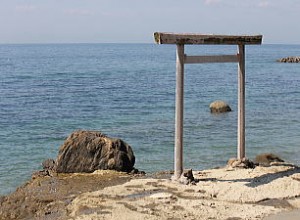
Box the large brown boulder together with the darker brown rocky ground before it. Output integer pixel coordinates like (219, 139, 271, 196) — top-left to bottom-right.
(0, 131, 143, 220)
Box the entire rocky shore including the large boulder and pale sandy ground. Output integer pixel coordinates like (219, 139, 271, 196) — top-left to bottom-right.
(0, 131, 300, 220)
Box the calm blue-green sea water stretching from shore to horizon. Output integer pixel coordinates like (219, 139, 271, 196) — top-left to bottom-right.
(0, 44, 300, 194)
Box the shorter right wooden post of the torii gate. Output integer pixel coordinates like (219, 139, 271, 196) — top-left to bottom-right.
(237, 45, 245, 159)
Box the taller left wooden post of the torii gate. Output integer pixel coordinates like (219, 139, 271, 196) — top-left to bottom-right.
(174, 44, 184, 179)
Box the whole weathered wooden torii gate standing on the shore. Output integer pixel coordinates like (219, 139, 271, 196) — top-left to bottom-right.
(154, 32, 262, 179)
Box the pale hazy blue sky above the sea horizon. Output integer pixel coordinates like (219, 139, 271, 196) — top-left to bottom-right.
(0, 0, 300, 44)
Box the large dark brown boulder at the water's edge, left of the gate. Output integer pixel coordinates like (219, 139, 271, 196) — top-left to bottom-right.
(56, 131, 135, 173)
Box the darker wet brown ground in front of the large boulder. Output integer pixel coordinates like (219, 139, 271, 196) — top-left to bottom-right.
(0, 171, 132, 220)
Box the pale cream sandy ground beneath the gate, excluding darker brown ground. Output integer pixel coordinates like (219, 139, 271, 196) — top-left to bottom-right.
(68, 164, 300, 220)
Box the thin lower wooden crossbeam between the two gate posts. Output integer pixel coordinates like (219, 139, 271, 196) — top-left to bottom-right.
(184, 55, 238, 64)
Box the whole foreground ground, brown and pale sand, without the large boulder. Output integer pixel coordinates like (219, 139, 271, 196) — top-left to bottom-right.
(0, 163, 300, 220)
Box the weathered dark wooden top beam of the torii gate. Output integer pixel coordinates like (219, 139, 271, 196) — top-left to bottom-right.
(154, 32, 262, 45)
